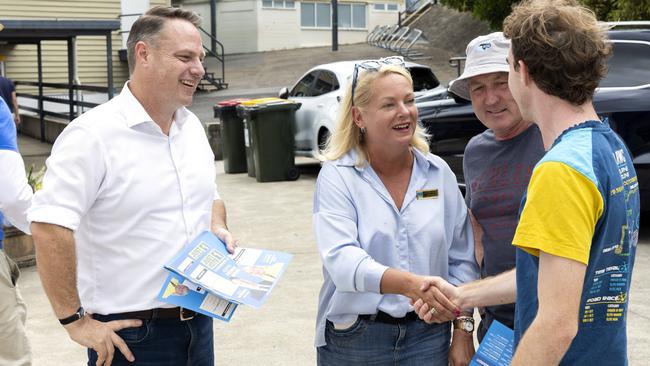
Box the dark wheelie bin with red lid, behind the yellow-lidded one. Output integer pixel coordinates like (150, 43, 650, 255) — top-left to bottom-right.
(214, 99, 247, 174)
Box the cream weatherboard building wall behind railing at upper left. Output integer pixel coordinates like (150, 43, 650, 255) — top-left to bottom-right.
(0, 0, 170, 93)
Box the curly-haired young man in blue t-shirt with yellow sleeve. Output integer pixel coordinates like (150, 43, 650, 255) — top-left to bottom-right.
(414, 1, 640, 366)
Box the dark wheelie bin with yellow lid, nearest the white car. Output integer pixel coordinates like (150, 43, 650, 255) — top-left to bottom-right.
(237, 98, 300, 182)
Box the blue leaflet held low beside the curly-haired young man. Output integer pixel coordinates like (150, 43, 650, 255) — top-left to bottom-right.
(469, 320, 515, 366)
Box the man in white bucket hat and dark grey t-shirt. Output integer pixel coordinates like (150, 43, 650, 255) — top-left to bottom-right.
(449, 32, 544, 341)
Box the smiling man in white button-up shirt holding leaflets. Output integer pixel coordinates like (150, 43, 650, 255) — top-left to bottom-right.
(29, 7, 235, 365)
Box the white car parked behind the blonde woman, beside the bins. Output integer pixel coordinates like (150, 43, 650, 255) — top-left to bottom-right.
(278, 61, 447, 158)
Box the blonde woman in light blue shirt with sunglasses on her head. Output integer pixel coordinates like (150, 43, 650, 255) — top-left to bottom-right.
(313, 56, 479, 366)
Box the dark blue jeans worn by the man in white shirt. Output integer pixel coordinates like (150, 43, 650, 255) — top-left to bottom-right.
(88, 314, 214, 366)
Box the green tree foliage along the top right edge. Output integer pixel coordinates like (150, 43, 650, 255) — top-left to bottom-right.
(441, 0, 650, 29)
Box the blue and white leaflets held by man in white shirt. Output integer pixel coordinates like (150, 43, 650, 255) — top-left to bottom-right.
(158, 231, 292, 321)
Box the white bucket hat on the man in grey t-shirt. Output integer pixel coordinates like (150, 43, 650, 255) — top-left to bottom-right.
(449, 32, 510, 100)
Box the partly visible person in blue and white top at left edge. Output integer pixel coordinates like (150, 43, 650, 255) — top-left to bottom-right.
(0, 98, 32, 366)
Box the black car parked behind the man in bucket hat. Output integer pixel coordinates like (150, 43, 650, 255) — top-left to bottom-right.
(417, 29, 650, 209)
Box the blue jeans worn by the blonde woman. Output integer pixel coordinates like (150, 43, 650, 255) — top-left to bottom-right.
(317, 317, 451, 366)
